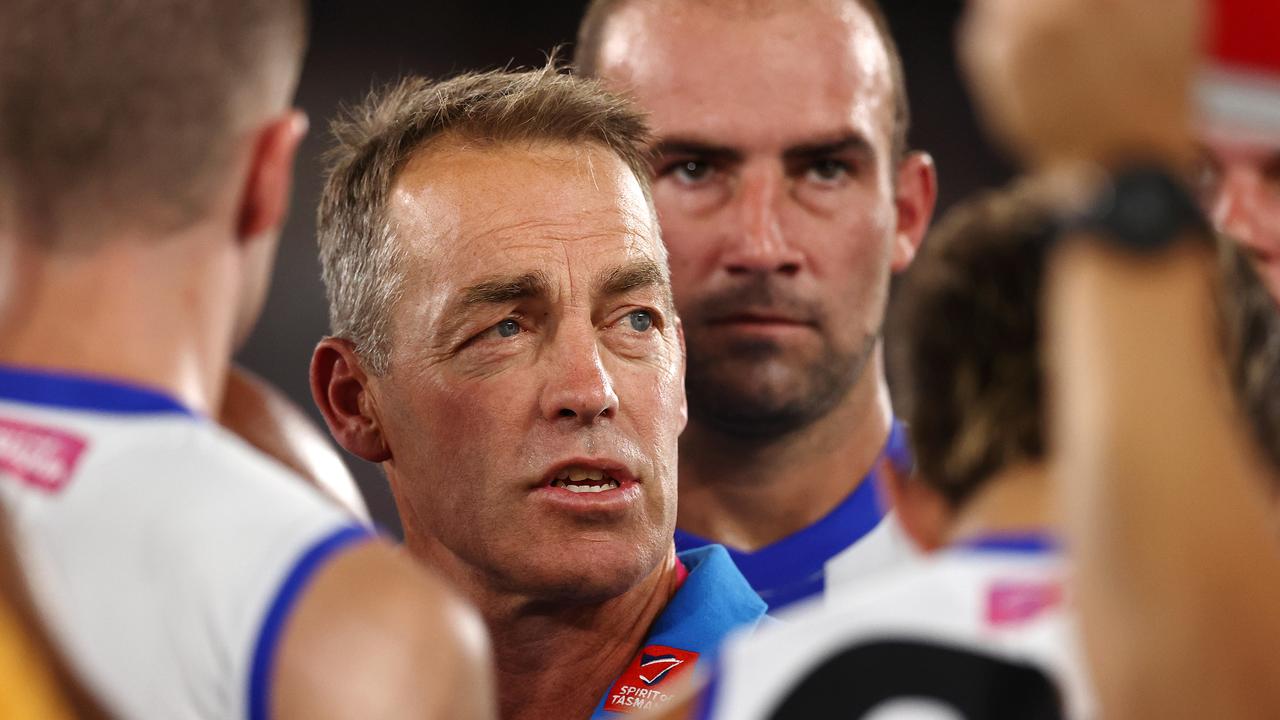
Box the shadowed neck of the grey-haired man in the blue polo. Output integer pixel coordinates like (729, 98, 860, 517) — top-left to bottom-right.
(406, 528, 677, 720)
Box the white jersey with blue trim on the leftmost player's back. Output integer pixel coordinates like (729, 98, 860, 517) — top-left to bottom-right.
(0, 366, 370, 719)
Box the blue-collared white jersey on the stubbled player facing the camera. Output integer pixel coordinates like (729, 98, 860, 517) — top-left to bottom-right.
(676, 423, 919, 614)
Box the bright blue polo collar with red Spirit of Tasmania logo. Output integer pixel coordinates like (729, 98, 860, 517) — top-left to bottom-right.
(591, 544, 768, 720)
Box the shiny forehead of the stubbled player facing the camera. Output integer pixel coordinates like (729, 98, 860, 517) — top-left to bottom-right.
(599, 0, 893, 151)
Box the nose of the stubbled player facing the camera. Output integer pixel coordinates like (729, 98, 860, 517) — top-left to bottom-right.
(722, 167, 804, 275)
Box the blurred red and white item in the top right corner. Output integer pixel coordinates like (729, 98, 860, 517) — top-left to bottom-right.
(1197, 0, 1280, 141)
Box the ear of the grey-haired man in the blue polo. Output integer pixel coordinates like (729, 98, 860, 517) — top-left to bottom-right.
(311, 337, 392, 462)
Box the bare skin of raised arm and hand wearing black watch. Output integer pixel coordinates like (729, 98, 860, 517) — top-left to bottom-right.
(964, 0, 1280, 717)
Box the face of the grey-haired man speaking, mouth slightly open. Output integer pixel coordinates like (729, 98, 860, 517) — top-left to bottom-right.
(372, 145, 685, 602)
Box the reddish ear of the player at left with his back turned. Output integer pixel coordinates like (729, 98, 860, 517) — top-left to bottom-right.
(236, 110, 307, 241)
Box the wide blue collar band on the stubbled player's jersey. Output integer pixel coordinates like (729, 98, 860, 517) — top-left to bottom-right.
(676, 421, 911, 612)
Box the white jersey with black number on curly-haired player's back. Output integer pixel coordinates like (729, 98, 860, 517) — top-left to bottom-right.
(700, 536, 1096, 720)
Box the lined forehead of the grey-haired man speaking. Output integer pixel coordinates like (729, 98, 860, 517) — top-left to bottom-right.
(388, 141, 667, 295)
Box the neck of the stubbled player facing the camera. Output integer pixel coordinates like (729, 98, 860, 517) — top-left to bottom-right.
(677, 348, 892, 551)
